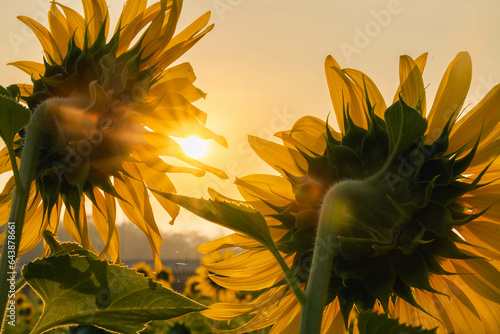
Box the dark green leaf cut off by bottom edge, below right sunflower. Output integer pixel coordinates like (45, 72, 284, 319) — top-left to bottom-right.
(358, 311, 437, 334)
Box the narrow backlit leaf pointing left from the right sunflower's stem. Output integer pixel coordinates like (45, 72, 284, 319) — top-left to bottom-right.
(155, 189, 276, 249)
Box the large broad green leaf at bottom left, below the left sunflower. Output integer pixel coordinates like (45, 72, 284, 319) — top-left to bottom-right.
(23, 252, 206, 334)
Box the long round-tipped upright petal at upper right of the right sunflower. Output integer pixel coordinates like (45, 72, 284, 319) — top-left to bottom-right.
(426, 52, 472, 144)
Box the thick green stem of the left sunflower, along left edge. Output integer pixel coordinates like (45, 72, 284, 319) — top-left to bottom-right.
(0, 103, 46, 327)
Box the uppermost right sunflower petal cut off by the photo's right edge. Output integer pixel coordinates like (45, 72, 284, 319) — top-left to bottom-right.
(448, 85, 500, 154)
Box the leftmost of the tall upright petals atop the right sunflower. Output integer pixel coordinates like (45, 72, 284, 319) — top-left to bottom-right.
(325, 56, 366, 132)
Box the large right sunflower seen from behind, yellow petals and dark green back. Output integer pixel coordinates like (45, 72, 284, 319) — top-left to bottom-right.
(198, 52, 500, 333)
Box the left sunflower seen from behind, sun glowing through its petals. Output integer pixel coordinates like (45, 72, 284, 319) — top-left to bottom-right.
(0, 0, 227, 270)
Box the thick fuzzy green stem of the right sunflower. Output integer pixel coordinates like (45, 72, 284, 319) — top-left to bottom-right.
(300, 187, 343, 334)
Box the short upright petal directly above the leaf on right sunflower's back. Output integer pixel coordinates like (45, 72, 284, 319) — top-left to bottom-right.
(396, 56, 426, 117)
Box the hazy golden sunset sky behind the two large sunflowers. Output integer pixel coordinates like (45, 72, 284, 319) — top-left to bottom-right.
(0, 0, 500, 240)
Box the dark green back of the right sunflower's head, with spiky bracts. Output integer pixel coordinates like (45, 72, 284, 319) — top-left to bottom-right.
(272, 94, 490, 314)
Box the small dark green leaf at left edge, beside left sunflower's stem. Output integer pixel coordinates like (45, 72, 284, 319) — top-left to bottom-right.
(0, 95, 31, 150)
